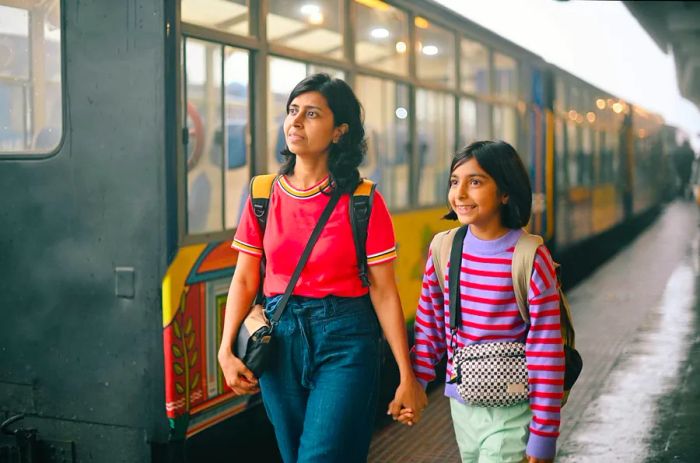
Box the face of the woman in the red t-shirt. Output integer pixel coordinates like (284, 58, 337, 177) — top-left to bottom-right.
(284, 92, 347, 157)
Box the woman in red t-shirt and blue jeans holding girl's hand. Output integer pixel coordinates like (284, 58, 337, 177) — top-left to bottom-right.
(219, 74, 427, 463)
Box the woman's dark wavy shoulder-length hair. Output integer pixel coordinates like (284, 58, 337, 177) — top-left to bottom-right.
(280, 73, 367, 193)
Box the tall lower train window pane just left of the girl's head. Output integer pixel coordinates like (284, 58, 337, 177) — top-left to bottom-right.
(416, 89, 455, 206)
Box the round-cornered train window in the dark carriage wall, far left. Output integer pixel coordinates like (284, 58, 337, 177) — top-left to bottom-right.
(0, 0, 63, 155)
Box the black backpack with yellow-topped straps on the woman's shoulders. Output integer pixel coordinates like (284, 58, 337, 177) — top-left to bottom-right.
(250, 174, 377, 286)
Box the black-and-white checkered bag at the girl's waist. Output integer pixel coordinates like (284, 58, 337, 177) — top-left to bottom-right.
(450, 342, 528, 407)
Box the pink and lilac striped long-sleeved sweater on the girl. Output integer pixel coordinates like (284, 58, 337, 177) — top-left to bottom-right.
(411, 230, 564, 458)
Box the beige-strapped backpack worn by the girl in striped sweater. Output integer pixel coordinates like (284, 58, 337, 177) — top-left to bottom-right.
(430, 227, 583, 406)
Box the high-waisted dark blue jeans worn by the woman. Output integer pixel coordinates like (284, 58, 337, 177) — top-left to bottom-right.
(260, 296, 381, 463)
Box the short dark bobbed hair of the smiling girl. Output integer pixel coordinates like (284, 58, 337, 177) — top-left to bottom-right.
(443, 141, 532, 229)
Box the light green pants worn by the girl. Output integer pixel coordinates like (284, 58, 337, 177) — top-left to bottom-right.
(450, 399, 532, 463)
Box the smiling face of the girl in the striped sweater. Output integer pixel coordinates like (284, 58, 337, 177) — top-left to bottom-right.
(447, 158, 508, 239)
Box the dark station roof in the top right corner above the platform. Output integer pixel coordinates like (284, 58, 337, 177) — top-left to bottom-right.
(623, 1, 700, 108)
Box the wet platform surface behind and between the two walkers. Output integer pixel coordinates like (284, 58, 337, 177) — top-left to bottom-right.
(368, 201, 700, 463)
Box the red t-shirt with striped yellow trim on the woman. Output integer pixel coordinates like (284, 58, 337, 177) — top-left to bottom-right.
(231, 176, 396, 298)
